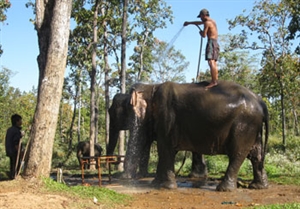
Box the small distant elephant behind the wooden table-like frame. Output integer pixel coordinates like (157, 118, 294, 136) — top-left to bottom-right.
(76, 141, 103, 169)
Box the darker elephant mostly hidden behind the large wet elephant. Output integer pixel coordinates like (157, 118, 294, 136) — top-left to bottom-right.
(106, 87, 207, 178)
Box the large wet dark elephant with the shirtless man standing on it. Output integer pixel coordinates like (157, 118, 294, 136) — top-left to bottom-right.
(127, 81, 269, 191)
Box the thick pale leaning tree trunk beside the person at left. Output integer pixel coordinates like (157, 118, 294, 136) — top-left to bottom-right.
(24, 0, 72, 178)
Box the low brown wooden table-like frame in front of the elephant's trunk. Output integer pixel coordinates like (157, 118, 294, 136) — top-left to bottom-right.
(80, 155, 125, 186)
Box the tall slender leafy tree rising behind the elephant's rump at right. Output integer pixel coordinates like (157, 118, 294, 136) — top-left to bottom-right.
(229, 0, 291, 146)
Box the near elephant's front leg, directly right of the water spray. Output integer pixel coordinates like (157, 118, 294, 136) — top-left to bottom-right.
(153, 139, 177, 189)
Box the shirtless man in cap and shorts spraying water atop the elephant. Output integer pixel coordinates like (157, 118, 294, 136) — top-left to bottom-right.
(183, 9, 220, 89)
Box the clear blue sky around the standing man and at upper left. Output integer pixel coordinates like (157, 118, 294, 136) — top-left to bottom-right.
(0, 0, 255, 91)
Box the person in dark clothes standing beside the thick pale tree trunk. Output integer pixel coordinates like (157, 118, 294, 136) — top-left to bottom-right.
(5, 114, 23, 179)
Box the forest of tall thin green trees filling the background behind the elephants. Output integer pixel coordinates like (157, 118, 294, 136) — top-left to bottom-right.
(0, 0, 300, 180)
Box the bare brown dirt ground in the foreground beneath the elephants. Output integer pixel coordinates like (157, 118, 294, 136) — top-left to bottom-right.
(0, 178, 300, 209)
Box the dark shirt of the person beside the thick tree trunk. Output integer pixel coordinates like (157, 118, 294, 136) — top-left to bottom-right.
(5, 126, 22, 157)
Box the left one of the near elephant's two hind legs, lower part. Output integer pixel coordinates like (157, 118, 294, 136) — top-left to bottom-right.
(216, 155, 246, 192)
